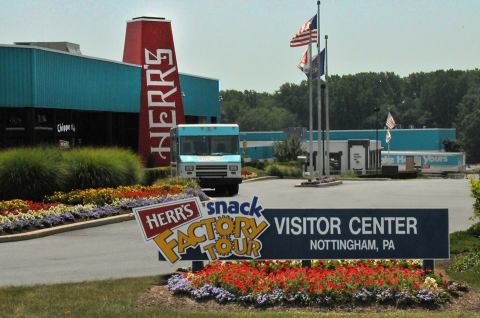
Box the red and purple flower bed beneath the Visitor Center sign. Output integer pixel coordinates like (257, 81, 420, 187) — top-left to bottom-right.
(168, 261, 466, 306)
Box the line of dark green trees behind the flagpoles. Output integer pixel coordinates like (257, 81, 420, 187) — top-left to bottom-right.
(221, 69, 480, 162)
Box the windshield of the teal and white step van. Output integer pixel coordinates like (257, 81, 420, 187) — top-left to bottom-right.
(179, 135, 239, 156)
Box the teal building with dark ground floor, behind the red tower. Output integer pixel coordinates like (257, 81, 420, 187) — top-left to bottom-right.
(0, 42, 220, 151)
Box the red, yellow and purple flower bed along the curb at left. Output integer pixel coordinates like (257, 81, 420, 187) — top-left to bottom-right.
(0, 185, 208, 235)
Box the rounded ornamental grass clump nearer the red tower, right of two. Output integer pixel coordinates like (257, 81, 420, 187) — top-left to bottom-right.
(64, 148, 143, 191)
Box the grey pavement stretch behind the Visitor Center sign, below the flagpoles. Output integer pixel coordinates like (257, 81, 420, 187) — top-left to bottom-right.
(231, 179, 473, 232)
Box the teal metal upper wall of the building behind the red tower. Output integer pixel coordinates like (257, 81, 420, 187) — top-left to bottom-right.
(0, 45, 220, 117)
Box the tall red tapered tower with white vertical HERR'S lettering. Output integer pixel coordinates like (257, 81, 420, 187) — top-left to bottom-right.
(123, 17, 185, 166)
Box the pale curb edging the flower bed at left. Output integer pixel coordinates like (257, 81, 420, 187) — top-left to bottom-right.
(0, 212, 135, 243)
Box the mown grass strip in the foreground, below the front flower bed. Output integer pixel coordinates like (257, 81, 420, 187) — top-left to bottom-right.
(0, 277, 480, 318)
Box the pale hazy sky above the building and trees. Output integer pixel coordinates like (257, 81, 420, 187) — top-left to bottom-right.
(0, 0, 480, 92)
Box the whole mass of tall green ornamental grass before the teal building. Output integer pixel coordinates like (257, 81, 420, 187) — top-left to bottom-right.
(0, 147, 144, 201)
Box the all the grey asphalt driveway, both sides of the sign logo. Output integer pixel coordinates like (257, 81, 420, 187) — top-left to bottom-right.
(0, 179, 473, 285)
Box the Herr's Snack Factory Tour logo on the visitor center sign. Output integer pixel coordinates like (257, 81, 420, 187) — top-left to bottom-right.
(133, 197, 270, 264)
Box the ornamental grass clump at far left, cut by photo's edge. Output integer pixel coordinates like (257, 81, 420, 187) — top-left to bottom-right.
(0, 147, 64, 200)
